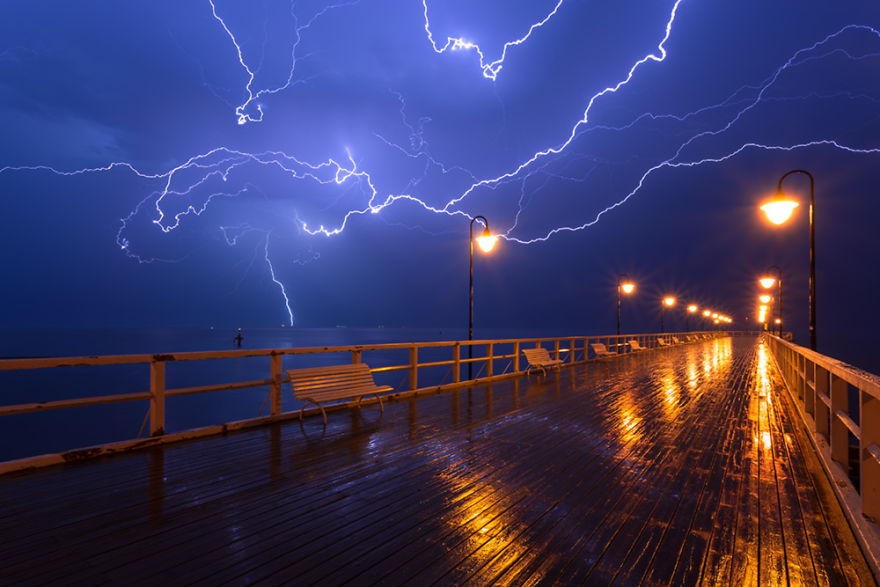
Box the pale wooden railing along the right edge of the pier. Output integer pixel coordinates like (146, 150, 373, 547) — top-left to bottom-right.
(766, 336, 880, 569)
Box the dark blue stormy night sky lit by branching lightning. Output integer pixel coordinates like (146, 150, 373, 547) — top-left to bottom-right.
(0, 0, 880, 350)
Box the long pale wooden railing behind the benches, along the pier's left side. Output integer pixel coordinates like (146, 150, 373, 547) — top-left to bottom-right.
(0, 331, 728, 474)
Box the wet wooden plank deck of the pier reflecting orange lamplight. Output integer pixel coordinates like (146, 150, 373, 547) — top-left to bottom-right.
(0, 338, 873, 585)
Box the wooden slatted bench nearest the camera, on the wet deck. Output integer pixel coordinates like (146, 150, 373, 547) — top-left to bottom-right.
(287, 363, 394, 425)
